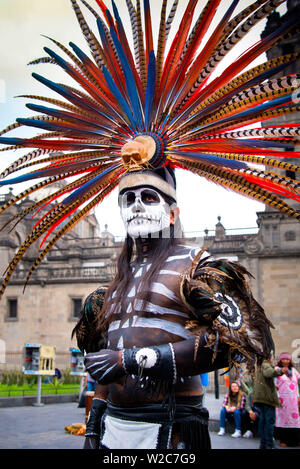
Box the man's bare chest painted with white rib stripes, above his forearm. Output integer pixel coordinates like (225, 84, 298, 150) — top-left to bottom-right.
(108, 262, 189, 349)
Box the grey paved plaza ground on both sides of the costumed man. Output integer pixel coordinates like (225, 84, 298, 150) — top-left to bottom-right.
(0, 394, 298, 450)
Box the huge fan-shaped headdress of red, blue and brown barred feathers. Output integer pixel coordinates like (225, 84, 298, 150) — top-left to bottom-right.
(0, 0, 300, 295)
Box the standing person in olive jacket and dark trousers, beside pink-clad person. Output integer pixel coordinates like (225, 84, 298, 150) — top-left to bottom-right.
(252, 356, 283, 449)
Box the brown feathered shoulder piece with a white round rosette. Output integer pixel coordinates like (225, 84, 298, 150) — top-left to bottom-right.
(181, 250, 274, 369)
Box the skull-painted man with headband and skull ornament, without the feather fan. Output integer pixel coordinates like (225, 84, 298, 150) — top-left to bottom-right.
(76, 136, 272, 449)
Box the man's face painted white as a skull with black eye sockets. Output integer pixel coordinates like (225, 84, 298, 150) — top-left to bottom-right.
(119, 187, 170, 238)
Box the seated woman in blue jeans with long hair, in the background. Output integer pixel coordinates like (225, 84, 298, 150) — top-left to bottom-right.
(218, 381, 246, 438)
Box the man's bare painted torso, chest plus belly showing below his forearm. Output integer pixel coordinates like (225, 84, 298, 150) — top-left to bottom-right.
(106, 245, 202, 405)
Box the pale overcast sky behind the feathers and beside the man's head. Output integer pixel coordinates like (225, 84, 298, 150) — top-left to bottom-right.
(0, 0, 284, 235)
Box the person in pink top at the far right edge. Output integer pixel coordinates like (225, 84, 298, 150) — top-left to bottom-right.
(275, 352, 300, 447)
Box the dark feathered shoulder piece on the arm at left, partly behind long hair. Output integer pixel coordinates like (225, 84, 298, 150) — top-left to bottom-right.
(72, 287, 107, 353)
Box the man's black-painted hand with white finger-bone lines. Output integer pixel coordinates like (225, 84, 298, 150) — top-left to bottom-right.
(84, 349, 125, 384)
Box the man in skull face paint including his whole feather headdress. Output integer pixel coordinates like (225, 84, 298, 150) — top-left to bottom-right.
(0, 0, 300, 449)
